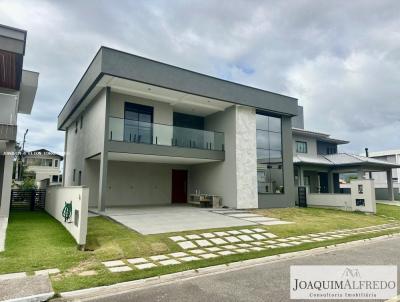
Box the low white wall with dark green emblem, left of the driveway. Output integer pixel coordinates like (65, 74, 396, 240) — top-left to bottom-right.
(45, 186, 89, 246)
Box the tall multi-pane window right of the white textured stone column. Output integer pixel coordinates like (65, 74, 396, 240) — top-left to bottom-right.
(257, 113, 284, 194)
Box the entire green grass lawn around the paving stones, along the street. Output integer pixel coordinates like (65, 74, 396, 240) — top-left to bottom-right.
(0, 205, 400, 292)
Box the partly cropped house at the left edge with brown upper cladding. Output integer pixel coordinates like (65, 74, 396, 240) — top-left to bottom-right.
(0, 25, 39, 217)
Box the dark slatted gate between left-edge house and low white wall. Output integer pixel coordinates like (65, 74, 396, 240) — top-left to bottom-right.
(10, 189, 46, 211)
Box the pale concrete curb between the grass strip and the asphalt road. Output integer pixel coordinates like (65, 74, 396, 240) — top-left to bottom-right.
(58, 233, 400, 301)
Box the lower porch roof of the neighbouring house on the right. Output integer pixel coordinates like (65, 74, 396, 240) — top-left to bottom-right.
(293, 153, 400, 169)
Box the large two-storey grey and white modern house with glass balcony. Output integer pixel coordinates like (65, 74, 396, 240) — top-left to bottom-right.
(58, 47, 298, 210)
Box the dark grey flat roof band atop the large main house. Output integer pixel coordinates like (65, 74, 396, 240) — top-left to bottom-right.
(58, 46, 298, 130)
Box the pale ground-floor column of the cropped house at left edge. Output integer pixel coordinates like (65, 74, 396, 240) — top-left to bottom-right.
(0, 142, 15, 217)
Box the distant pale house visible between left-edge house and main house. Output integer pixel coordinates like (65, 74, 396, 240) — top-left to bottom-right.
(24, 149, 63, 185)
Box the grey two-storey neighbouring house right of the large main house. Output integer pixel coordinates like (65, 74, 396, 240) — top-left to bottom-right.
(293, 111, 400, 200)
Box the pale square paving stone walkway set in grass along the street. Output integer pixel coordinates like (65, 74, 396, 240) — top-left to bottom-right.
(99, 222, 400, 273)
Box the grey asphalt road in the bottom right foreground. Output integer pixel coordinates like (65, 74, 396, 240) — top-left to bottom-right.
(79, 237, 400, 302)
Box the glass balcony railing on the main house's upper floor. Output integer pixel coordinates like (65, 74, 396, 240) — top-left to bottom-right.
(108, 117, 224, 151)
